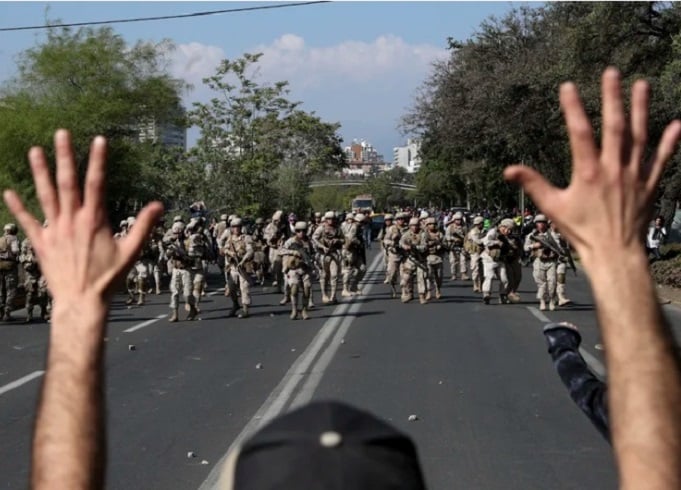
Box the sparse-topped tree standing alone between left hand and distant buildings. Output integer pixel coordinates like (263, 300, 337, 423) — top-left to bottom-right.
(189, 53, 344, 214)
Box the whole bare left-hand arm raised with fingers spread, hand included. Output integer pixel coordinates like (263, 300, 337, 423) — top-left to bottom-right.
(4, 130, 162, 490)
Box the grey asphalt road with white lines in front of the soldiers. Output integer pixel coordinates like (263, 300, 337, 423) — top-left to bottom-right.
(0, 249, 681, 490)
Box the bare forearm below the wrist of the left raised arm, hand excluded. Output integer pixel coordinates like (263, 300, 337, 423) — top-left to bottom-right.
(31, 300, 107, 489)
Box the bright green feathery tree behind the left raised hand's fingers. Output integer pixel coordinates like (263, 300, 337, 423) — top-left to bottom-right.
(0, 23, 186, 222)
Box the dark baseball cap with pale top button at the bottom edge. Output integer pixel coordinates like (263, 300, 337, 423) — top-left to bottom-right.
(220, 401, 425, 490)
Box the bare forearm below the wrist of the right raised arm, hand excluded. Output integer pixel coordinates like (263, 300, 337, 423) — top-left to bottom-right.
(585, 248, 681, 489)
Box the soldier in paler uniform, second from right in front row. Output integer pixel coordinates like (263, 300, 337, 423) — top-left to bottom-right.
(480, 218, 514, 305)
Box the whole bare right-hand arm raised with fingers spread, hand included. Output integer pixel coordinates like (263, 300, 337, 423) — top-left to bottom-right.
(505, 69, 681, 489)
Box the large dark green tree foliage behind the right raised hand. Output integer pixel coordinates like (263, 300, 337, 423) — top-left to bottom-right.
(402, 2, 681, 212)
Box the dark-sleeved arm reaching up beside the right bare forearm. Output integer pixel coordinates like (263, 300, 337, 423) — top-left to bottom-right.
(544, 326, 610, 442)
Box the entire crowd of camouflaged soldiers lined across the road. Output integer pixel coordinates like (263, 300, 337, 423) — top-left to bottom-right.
(0, 207, 574, 322)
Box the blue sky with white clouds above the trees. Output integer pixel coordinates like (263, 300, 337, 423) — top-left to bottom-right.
(0, 2, 520, 160)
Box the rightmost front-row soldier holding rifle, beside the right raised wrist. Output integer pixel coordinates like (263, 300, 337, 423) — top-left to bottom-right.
(525, 214, 558, 311)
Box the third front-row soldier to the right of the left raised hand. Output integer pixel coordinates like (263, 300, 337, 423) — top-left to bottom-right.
(281, 221, 314, 320)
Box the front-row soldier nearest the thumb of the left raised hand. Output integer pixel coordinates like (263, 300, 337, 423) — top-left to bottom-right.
(164, 221, 198, 322)
